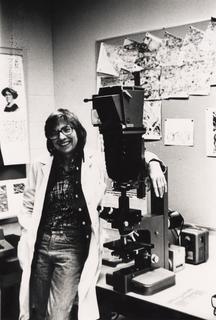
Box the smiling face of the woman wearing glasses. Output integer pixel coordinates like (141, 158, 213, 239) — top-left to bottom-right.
(50, 119, 78, 156)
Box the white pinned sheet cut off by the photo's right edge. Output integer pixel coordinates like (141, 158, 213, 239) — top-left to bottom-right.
(205, 108, 216, 157)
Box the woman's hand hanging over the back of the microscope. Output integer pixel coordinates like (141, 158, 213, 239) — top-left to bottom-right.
(148, 160, 167, 198)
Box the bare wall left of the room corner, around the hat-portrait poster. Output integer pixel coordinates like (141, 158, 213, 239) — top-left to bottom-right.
(0, 0, 54, 160)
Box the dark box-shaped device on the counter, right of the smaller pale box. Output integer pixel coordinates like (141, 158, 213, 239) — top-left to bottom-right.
(181, 227, 209, 264)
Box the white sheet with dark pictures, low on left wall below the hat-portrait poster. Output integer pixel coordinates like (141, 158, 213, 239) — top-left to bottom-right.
(0, 179, 26, 220)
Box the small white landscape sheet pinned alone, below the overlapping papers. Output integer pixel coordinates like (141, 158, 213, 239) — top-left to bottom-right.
(164, 119, 194, 146)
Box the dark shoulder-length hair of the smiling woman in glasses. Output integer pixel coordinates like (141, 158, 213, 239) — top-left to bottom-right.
(44, 108, 87, 159)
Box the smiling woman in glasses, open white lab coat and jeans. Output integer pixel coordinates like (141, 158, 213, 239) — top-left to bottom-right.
(18, 109, 166, 320)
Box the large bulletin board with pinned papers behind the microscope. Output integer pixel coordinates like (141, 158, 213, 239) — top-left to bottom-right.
(96, 17, 216, 229)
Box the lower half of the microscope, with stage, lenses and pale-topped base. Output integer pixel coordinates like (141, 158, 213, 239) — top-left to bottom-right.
(99, 175, 175, 295)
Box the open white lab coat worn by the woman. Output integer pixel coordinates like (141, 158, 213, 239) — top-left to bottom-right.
(18, 148, 162, 320)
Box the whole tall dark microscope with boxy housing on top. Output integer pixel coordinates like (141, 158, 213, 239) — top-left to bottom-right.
(85, 86, 175, 294)
